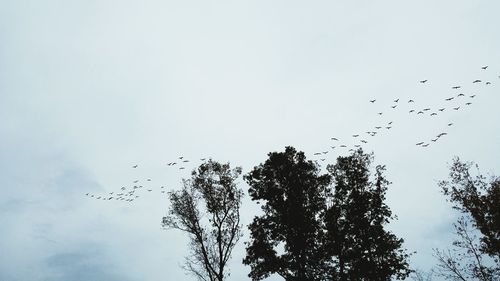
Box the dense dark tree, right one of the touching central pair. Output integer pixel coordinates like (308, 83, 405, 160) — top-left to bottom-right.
(324, 149, 412, 280)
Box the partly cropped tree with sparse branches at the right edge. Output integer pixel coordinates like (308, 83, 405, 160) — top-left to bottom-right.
(435, 158, 500, 281)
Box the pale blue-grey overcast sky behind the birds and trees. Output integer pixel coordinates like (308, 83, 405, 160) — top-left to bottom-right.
(0, 0, 500, 281)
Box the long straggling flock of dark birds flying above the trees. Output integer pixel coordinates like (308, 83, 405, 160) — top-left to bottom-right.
(85, 66, 500, 202)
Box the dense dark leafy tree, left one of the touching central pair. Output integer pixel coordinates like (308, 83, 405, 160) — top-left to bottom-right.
(243, 147, 330, 281)
